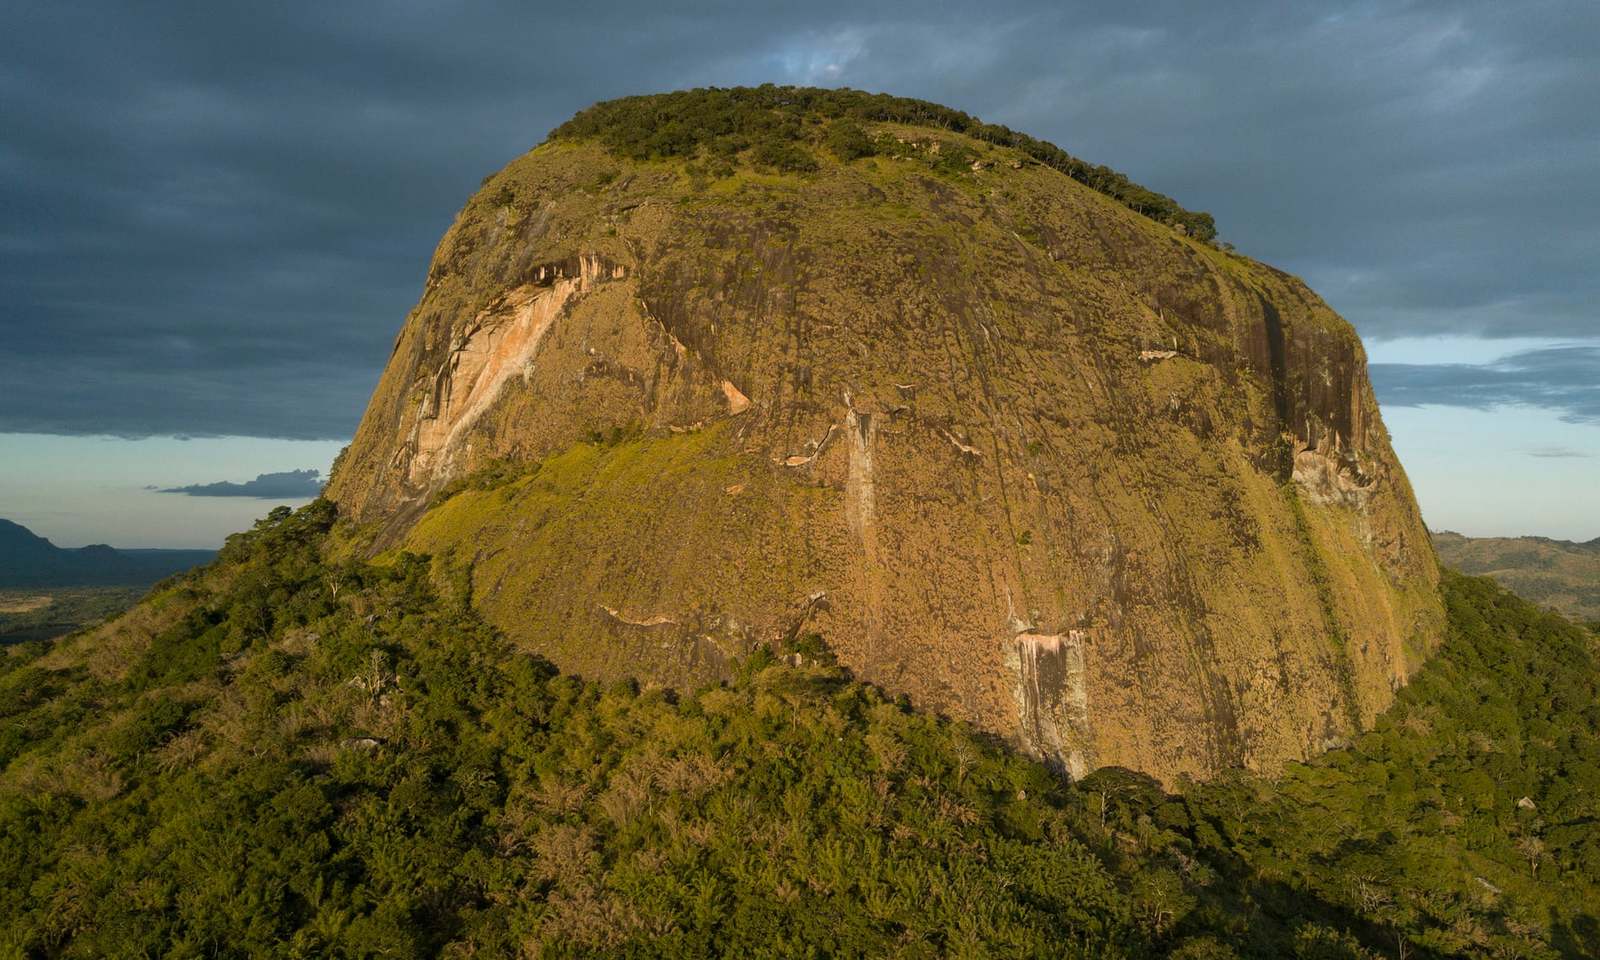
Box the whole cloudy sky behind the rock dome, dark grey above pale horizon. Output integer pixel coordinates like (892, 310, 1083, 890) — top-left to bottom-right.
(0, 0, 1600, 546)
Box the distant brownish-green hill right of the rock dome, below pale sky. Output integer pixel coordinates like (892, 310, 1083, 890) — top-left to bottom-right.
(1434, 530, 1600, 622)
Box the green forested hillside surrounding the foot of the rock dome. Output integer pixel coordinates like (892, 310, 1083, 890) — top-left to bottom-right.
(0, 501, 1600, 960)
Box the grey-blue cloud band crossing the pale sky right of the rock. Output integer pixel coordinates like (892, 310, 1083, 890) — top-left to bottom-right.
(1371, 346, 1600, 422)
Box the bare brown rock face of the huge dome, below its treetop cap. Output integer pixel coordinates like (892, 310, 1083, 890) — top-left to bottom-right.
(330, 90, 1443, 779)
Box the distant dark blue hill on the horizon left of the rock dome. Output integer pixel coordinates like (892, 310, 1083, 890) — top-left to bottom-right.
(0, 520, 216, 587)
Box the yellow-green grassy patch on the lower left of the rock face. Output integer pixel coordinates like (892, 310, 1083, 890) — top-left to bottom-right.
(405, 424, 838, 685)
